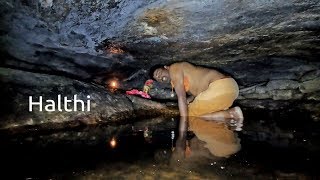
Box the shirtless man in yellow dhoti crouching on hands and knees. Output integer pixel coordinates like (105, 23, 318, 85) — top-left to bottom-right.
(153, 62, 243, 125)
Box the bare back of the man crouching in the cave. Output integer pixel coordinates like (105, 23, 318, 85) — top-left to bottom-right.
(169, 62, 227, 96)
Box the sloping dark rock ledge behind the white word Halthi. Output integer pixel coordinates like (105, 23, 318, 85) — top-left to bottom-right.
(0, 68, 177, 131)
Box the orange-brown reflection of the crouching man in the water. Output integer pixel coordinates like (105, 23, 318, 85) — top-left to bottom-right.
(173, 117, 241, 164)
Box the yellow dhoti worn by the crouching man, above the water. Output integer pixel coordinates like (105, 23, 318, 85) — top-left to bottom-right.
(188, 78, 239, 116)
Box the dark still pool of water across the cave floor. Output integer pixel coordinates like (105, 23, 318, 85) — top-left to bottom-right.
(1, 114, 320, 179)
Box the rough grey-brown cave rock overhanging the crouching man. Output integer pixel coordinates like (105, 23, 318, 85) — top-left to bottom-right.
(0, 0, 320, 124)
